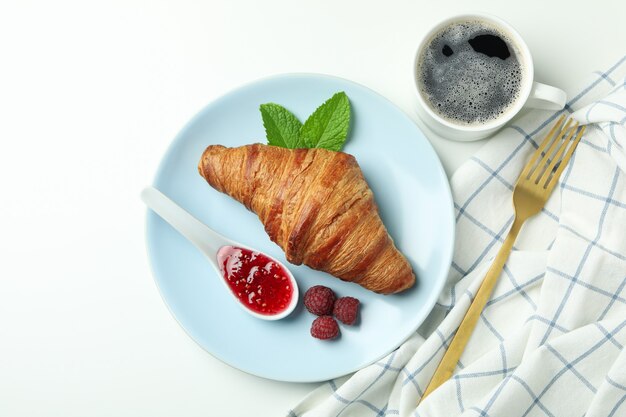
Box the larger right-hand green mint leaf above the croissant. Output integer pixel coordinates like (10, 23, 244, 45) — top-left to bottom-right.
(300, 91, 350, 151)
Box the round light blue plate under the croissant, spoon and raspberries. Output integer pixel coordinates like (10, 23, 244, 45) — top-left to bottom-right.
(147, 74, 454, 382)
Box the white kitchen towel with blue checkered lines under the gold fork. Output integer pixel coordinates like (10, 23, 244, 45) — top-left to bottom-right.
(289, 56, 626, 417)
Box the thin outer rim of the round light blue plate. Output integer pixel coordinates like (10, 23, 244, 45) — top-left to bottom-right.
(144, 72, 456, 383)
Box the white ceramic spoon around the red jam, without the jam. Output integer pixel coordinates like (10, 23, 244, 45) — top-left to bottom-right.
(141, 187, 298, 320)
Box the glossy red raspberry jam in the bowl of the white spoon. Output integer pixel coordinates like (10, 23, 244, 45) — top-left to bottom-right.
(217, 246, 293, 316)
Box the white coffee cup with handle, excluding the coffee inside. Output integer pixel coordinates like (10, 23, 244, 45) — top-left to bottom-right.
(413, 13, 566, 141)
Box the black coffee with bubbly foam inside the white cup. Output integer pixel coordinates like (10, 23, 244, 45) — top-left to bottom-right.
(417, 20, 523, 126)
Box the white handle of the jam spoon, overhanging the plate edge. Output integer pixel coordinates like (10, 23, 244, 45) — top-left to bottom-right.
(141, 187, 223, 258)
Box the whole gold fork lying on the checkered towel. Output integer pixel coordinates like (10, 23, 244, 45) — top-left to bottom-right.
(422, 116, 585, 400)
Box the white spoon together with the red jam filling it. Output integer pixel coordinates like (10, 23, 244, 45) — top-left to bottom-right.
(141, 187, 298, 320)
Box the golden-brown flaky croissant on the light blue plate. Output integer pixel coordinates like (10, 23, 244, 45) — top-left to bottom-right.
(198, 144, 415, 294)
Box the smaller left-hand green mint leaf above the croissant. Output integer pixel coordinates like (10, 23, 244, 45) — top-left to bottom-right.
(259, 103, 303, 149)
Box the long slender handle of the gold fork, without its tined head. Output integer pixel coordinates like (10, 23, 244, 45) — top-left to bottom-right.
(420, 216, 524, 401)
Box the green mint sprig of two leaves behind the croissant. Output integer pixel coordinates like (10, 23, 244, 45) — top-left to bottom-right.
(260, 91, 350, 151)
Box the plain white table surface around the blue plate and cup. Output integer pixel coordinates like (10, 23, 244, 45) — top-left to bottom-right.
(0, 0, 626, 417)
